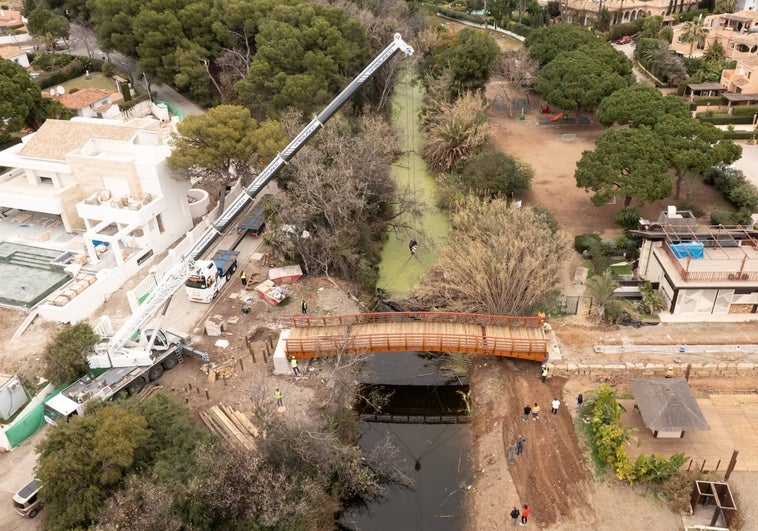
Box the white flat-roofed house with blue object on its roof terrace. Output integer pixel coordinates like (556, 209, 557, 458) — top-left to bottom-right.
(637, 207, 758, 322)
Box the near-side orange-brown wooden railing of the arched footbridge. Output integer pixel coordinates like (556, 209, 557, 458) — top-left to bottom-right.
(285, 332, 547, 361)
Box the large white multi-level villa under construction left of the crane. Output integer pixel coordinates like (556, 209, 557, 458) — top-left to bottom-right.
(0, 118, 192, 267)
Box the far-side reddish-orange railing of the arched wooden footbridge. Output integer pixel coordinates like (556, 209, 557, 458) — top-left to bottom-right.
(289, 312, 541, 328)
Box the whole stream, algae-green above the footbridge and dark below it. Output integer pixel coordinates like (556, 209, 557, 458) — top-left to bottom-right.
(340, 72, 472, 531)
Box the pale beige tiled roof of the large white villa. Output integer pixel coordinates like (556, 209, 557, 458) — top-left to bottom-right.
(19, 120, 137, 160)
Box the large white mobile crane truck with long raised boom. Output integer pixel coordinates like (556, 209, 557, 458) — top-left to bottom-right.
(45, 33, 414, 423)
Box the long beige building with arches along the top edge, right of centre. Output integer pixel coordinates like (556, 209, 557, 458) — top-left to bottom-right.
(563, 0, 697, 26)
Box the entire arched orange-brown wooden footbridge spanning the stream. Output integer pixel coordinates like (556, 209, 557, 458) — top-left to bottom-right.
(282, 312, 547, 362)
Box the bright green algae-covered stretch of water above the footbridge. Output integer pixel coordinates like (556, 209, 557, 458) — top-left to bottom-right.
(377, 71, 449, 297)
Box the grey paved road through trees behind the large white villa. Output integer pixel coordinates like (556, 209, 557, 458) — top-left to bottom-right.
(68, 24, 205, 114)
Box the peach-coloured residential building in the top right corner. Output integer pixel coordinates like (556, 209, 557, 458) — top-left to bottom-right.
(671, 11, 758, 59)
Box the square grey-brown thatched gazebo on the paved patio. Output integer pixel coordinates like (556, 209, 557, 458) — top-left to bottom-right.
(629, 378, 711, 438)
